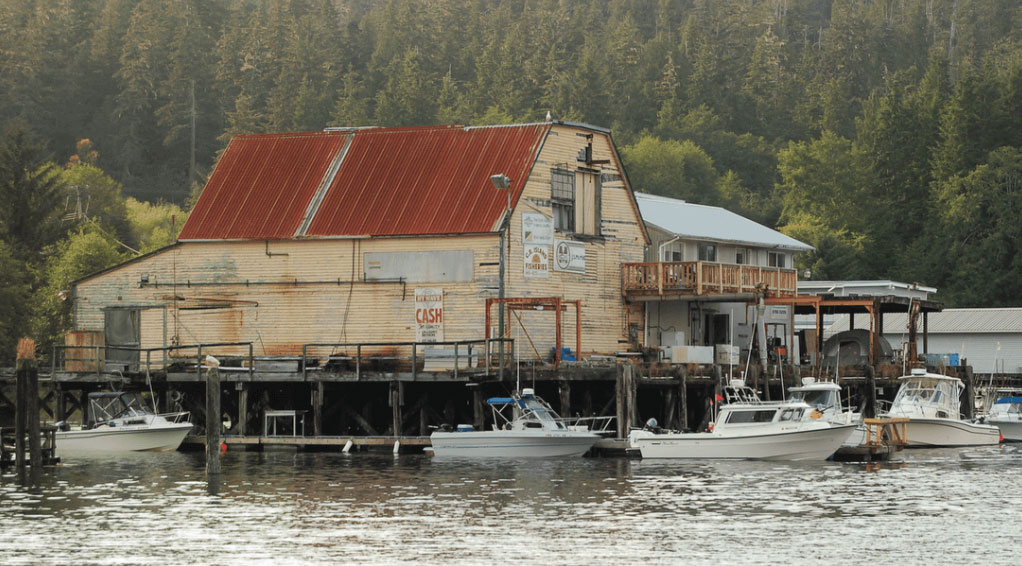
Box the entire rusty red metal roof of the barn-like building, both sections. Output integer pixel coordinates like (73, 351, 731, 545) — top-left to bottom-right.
(180, 124, 550, 240)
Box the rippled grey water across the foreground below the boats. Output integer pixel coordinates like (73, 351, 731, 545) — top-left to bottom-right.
(0, 446, 1022, 566)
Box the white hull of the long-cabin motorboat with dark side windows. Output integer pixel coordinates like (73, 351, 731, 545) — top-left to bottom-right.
(631, 424, 855, 461)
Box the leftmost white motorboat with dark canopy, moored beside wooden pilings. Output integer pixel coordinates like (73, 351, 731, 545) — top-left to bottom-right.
(56, 391, 192, 456)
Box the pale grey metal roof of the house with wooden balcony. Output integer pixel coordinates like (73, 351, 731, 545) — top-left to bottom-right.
(636, 193, 814, 251)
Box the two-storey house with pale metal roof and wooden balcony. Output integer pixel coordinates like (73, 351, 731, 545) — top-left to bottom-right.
(622, 193, 814, 362)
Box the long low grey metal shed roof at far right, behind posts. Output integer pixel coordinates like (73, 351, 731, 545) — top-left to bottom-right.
(827, 308, 1022, 334)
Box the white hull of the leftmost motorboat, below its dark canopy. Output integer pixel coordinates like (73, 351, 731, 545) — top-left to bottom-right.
(56, 423, 192, 456)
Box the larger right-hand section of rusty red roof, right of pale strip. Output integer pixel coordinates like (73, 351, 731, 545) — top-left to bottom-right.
(306, 124, 549, 237)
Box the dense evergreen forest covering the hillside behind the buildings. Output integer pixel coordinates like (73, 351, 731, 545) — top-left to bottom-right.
(0, 0, 1022, 361)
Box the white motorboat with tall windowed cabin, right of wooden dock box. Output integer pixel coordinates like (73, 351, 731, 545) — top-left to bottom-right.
(883, 369, 1001, 447)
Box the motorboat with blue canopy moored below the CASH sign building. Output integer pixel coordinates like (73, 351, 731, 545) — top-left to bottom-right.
(429, 388, 600, 458)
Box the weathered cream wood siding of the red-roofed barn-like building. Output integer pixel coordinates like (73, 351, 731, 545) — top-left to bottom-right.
(75, 127, 645, 361)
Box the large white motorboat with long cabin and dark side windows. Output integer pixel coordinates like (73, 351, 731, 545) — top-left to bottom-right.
(629, 382, 856, 460)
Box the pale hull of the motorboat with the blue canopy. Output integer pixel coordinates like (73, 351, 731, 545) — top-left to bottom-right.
(429, 430, 599, 458)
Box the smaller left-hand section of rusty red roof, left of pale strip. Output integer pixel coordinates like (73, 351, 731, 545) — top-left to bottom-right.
(178, 132, 351, 240)
